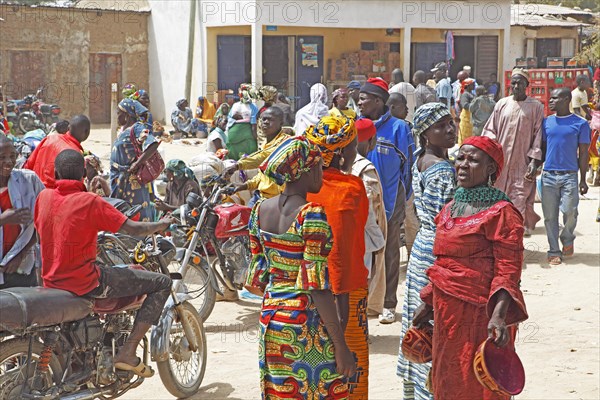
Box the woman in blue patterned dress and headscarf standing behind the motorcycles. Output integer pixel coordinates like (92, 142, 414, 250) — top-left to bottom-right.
(110, 99, 158, 221)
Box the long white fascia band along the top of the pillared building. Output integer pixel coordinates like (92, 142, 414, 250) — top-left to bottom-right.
(201, 0, 510, 29)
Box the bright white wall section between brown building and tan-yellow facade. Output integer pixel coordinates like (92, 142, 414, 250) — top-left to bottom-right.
(148, 0, 190, 123)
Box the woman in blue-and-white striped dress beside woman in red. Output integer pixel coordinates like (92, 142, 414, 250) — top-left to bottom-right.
(396, 103, 456, 400)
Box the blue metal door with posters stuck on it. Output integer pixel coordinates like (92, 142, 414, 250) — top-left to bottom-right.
(295, 36, 323, 110)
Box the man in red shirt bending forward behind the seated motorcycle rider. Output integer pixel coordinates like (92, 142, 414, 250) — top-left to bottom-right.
(23, 115, 91, 189)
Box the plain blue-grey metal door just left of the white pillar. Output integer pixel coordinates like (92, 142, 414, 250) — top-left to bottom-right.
(217, 36, 251, 93)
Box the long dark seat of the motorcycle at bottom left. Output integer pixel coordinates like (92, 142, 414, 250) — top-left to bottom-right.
(0, 287, 93, 334)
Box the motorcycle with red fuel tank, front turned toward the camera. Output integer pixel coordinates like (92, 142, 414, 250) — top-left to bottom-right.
(174, 175, 251, 320)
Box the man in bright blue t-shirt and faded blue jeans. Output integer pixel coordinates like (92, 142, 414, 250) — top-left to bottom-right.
(542, 88, 590, 265)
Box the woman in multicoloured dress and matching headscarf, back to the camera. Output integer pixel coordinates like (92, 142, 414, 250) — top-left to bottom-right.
(247, 137, 356, 400)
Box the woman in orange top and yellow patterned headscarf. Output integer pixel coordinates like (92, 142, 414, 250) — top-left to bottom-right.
(305, 117, 369, 399)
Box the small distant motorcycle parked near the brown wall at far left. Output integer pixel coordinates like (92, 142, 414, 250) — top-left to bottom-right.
(17, 87, 61, 134)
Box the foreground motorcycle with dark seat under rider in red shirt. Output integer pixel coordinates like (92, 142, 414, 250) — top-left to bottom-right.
(0, 217, 207, 400)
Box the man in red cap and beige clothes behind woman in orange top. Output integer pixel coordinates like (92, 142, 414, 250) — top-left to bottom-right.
(352, 118, 387, 315)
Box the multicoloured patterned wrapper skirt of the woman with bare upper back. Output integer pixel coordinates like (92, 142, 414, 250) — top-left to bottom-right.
(259, 292, 349, 400)
